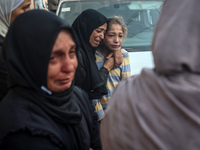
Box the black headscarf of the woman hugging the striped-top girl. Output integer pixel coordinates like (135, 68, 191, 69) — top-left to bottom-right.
(72, 9, 107, 99)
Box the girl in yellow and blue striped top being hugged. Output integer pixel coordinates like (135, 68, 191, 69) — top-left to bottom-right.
(95, 16, 131, 110)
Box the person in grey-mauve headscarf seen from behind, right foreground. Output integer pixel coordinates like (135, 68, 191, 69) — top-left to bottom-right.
(101, 0, 200, 150)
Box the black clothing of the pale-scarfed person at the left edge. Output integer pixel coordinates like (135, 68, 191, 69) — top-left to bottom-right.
(0, 35, 8, 101)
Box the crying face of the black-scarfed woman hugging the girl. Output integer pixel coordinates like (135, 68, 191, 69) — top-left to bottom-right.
(89, 23, 107, 47)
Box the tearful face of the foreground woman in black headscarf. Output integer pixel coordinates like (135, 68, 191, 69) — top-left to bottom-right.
(47, 30, 78, 92)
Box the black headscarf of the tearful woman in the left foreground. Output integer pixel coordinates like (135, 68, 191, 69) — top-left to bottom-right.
(5, 10, 81, 124)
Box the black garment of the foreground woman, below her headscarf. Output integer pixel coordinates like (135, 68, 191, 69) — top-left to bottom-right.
(0, 87, 101, 150)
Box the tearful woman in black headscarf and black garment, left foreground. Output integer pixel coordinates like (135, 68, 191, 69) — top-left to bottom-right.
(0, 10, 101, 150)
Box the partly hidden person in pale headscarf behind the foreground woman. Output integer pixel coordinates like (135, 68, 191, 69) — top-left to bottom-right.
(0, 0, 31, 101)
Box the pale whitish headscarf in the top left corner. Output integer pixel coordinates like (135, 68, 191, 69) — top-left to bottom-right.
(0, 0, 24, 37)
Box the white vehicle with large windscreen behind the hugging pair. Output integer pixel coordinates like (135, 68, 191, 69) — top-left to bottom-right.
(56, 0, 164, 75)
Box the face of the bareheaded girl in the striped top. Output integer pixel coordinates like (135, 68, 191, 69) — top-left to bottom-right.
(104, 24, 123, 51)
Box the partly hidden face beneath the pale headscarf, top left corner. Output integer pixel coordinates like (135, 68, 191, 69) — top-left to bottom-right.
(10, 0, 31, 23)
